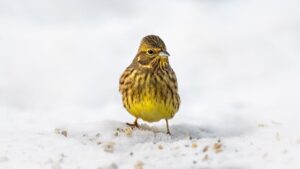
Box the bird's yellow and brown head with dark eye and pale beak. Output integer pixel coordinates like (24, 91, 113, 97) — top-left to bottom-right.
(134, 35, 169, 68)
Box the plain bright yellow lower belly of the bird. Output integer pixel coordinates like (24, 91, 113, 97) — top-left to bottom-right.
(129, 96, 175, 122)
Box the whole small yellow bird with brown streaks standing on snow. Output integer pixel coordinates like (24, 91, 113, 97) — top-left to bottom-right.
(119, 35, 180, 134)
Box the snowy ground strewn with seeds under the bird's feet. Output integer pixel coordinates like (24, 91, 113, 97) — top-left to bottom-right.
(0, 112, 300, 169)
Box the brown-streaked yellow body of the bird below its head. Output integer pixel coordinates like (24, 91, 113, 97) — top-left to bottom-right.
(120, 65, 180, 122)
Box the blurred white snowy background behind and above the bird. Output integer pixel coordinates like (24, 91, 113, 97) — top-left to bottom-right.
(0, 0, 300, 128)
